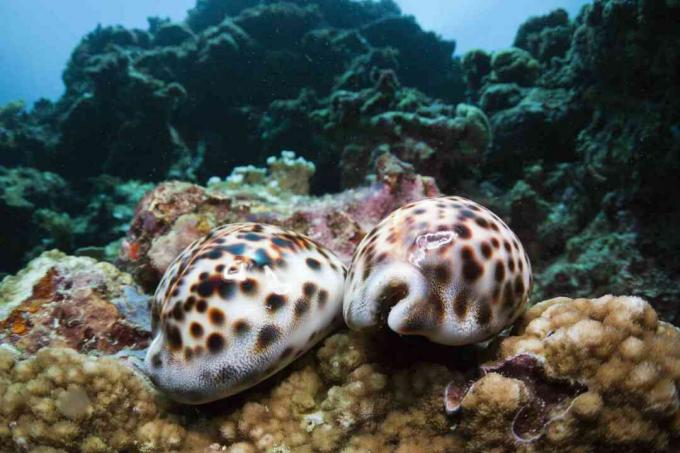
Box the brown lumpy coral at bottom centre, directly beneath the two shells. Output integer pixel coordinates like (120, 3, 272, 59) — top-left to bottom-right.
(220, 332, 462, 452)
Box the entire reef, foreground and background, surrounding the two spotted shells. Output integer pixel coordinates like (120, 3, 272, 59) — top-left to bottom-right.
(0, 0, 680, 453)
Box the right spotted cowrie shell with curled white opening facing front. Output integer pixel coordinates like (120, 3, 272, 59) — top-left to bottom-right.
(343, 196, 532, 345)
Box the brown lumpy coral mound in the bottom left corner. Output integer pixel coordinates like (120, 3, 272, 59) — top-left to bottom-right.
(0, 348, 184, 452)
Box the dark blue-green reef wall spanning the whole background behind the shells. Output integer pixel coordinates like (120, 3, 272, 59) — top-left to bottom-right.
(0, 0, 680, 328)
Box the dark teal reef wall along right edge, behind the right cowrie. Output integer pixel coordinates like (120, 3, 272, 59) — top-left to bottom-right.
(462, 0, 680, 322)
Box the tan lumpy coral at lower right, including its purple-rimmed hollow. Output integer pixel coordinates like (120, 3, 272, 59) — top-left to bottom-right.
(460, 296, 680, 451)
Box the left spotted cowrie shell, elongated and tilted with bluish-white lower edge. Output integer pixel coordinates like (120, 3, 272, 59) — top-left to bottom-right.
(145, 223, 345, 403)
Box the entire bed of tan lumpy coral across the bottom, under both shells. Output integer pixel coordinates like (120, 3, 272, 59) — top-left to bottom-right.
(0, 296, 680, 452)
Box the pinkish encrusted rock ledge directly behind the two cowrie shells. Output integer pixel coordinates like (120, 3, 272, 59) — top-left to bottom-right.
(120, 155, 440, 291)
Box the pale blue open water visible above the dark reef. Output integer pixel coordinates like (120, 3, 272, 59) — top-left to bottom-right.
(0, 0, 588, 106)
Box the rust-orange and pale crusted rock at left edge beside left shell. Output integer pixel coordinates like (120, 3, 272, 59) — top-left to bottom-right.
(0, 250, 150, 353)
